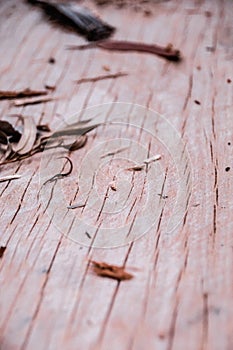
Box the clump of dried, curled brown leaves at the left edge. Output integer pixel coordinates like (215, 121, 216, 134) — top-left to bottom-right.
(0, 115, 100, 165)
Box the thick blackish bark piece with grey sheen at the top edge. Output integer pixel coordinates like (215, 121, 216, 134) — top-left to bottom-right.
(27, 0, 115, 41)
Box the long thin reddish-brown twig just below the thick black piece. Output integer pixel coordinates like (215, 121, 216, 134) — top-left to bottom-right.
(68, 40, 181, 62)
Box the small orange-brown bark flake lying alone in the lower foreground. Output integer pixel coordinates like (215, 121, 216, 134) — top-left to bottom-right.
(90, 260, 134, 281)
